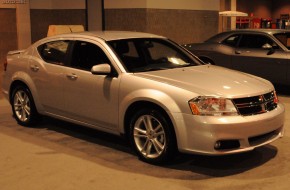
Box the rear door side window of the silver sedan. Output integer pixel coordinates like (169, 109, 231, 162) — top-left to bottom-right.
(37, 40, 69, 65)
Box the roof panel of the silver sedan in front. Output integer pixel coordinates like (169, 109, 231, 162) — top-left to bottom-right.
(45, 31, 165, 41)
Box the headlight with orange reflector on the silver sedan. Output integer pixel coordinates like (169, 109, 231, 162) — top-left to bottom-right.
(188, 97, 238, 116)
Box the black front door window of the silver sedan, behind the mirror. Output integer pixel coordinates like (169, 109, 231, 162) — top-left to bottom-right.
(71, 41, 110, 71)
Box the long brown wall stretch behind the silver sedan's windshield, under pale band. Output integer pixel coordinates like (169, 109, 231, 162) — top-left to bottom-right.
(105, 9, 219, 44)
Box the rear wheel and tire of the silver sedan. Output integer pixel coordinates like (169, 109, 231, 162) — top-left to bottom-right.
(11, 85, 38, 126)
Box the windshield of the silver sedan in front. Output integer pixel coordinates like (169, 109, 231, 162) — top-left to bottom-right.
(108, 38, 202, 72)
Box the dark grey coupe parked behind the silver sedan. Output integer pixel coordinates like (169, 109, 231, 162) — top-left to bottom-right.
(184, 29, 290, 86)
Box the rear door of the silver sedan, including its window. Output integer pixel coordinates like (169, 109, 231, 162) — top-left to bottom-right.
(29, 40, 70, 115)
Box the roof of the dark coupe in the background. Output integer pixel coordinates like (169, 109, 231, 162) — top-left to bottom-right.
(205, 29, 290, 42)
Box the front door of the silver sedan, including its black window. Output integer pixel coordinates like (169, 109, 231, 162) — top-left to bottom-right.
(63, 41, 120, 130)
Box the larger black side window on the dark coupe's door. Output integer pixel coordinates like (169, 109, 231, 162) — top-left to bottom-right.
(239, 34, 277, 49)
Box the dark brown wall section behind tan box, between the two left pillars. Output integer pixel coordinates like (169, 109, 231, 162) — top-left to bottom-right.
(30, 9, 86, 43)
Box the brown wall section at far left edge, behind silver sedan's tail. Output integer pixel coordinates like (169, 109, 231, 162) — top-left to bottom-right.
(0, 9, 17, 72)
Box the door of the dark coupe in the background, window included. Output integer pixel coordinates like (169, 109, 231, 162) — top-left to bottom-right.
(232, 34, 289, 83)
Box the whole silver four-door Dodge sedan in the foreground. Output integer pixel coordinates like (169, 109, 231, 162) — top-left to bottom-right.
(2, 31, 285, 163)
